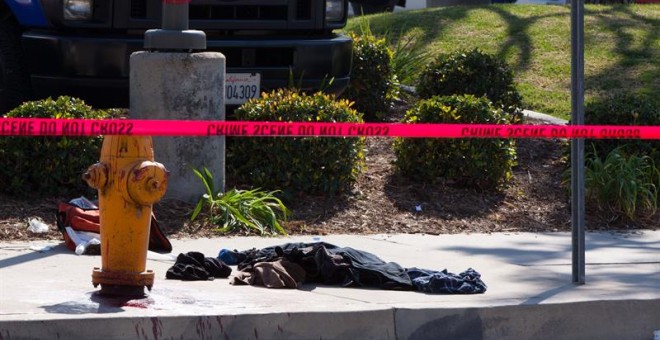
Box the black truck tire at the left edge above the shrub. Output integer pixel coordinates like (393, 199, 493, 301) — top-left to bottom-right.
(0, 19, 30, 116)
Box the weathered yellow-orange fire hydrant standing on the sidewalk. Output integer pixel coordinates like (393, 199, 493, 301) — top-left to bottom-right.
(83, 136, 168, 296)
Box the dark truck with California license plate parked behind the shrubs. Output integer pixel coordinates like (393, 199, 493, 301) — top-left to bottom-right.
(0, 0, 352, 111)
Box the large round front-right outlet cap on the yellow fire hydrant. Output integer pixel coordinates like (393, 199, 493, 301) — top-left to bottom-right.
(127, 161, 168, 205)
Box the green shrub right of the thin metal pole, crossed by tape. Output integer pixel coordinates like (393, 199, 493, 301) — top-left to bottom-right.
(584, 93, 660, 164)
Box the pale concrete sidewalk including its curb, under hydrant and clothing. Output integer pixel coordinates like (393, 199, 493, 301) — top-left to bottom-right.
(0, 231, 660, 339)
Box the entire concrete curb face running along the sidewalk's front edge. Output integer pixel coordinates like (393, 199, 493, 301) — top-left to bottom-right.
(0, 300, 660, 340)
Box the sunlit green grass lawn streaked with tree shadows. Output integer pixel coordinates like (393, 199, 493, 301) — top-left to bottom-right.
(345, 4, 660, 119)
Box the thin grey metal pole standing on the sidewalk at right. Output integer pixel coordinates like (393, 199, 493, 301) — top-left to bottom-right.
(571, 0, 585, 284)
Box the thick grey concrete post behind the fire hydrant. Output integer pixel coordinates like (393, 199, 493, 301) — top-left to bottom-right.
(130, 52, 225, 203)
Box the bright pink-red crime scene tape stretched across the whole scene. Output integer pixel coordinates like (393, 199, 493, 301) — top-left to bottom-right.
(0, 118, 660, 139)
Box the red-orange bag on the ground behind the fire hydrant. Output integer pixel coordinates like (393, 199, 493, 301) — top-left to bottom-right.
(57, 202, 172, 253)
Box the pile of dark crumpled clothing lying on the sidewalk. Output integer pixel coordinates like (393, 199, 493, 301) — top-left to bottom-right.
(166, 242, 487, 294)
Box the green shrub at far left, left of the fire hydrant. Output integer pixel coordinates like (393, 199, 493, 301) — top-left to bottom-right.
(0, 97, 107, 196)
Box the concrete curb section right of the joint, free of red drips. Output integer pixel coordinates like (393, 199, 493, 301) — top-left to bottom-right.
(395, 300, 660, 340)
